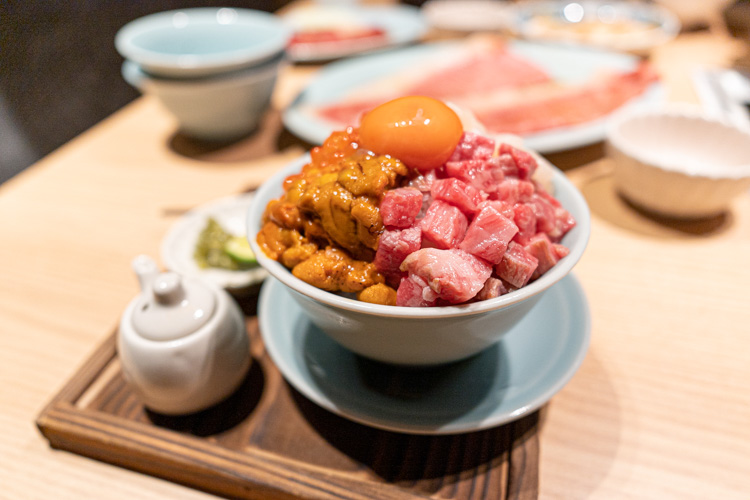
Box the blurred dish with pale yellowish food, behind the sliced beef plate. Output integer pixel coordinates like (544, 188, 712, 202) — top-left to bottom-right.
(511, 0, 681, 54)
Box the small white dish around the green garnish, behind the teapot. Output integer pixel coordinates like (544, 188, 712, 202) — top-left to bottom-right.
(161, 194, 267, 290)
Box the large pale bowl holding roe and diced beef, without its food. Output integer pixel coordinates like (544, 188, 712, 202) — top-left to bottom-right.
(247, 157, 590, 365)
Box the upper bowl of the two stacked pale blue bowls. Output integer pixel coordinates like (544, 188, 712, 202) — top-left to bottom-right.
(115, 8, 290, 78)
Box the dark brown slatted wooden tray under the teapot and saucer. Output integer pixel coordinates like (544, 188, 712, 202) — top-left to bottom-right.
(37, 296, 539, 499)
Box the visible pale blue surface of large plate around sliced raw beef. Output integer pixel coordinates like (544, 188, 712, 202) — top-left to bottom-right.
(283, 41, 663, 153)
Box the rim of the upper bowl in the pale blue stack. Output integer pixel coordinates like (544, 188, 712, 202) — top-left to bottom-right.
(115, 7, 291, 76)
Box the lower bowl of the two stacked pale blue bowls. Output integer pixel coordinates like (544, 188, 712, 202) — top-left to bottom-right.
(122, 55, 284, 141)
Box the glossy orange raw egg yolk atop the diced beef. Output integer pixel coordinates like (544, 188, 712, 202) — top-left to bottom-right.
(359, 96, 463, 171)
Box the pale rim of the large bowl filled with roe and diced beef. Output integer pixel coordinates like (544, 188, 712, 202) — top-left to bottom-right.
(246, 154, 591, 319)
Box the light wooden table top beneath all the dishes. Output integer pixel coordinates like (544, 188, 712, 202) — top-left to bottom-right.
(0, 22, 750, 500)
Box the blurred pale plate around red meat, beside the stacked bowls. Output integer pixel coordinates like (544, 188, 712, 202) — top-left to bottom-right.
(282, 4, 427, 62)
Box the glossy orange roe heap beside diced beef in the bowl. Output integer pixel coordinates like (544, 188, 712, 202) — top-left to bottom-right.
(257, 129, 409, 301)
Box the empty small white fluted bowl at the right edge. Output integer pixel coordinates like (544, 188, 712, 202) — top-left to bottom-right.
(606, 108, 750, 218)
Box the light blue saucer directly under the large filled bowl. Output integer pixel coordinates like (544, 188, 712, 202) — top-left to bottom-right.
(258, 275, 591, 434)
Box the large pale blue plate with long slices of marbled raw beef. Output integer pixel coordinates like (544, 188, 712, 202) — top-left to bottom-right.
(283, 37, 663, 153)
